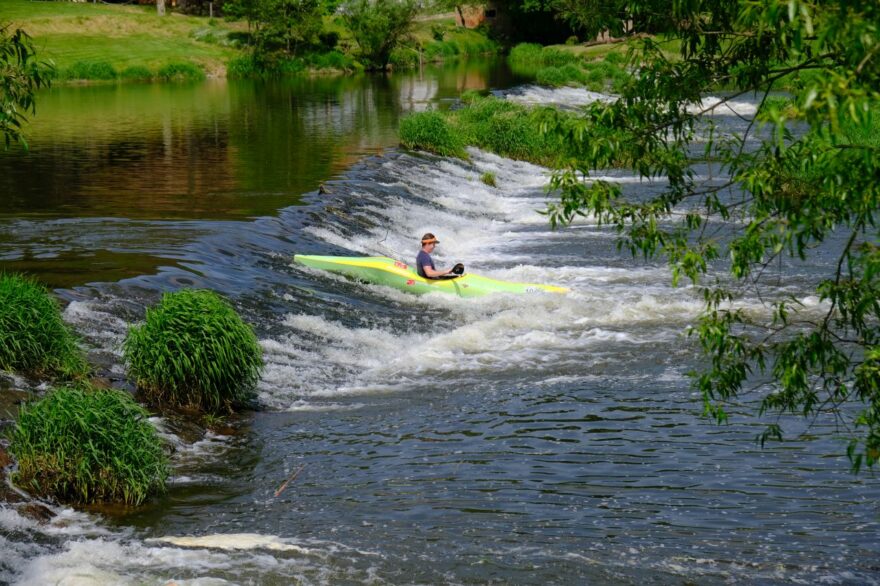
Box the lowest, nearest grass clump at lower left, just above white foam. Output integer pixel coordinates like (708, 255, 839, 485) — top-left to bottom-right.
(9, 388, 168, 505)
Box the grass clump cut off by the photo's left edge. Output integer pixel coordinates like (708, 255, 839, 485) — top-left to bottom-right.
(0, 273, 87, 377)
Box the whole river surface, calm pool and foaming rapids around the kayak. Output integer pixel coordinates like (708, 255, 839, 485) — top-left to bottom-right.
(0, 64, 880, 584)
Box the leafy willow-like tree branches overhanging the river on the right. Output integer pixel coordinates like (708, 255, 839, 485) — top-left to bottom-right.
(545, 0, 880, 470)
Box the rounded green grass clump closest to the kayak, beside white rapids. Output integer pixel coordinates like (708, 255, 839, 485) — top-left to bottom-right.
(123, 290, 263, 413)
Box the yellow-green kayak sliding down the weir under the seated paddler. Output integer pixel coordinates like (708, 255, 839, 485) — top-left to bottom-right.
(293, 254, 568, 297)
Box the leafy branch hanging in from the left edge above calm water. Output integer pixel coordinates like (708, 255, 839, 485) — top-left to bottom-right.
(0, 25, 51, 149)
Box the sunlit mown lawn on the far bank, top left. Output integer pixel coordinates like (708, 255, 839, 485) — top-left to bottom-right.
(0, 0, 246, 76)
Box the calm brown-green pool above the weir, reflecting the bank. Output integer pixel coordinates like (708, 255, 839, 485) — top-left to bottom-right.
(0, 61, 517, 286)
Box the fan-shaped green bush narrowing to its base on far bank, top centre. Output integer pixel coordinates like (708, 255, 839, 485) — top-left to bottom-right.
(342, 0, 418, 70)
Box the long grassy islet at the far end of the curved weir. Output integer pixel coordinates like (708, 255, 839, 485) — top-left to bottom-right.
(400, 94, 575, 165)
